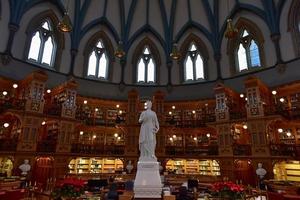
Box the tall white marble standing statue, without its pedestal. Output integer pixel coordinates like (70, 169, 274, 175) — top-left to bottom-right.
(139, 101, 159, 161)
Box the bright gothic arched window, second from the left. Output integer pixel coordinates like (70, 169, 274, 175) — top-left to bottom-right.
(87, 40, 109, 79)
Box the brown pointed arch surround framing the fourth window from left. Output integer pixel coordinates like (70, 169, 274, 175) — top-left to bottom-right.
(180, 33, 209, 82)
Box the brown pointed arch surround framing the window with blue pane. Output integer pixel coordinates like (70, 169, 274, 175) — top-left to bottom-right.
(227, 17, 266, 75)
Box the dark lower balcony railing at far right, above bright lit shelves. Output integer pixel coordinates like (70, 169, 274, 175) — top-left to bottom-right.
(270, 144, 298, 157)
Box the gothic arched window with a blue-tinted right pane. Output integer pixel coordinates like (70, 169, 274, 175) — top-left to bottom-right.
(236, 29, 261, 72)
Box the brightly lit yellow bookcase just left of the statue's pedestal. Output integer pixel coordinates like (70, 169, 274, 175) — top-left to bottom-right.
(69, 158, 124, 174)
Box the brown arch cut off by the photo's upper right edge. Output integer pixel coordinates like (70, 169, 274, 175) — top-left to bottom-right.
(287, 0, 300, 56)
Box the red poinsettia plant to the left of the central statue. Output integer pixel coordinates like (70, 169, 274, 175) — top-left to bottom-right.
(52, 178, 85, 199)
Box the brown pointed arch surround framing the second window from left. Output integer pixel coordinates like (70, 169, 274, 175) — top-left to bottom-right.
(83, 31, 115, 80)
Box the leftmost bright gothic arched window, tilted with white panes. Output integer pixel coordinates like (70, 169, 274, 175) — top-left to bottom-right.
(27, 19, 56, 67)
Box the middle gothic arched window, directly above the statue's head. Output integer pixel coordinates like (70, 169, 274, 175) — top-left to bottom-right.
(137, 46, 156, 83)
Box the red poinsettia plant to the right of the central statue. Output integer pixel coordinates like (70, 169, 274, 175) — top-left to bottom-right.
(212, 181, 245, 199)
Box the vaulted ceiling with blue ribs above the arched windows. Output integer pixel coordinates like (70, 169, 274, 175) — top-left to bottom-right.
(10, 0, 286, 58)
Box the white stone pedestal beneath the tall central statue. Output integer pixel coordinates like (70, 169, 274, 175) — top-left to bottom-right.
(133, 161, 162, 199)
